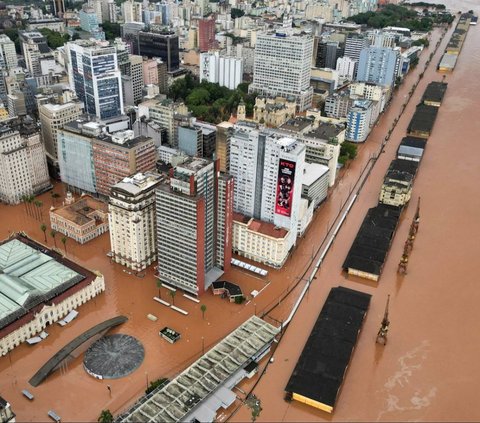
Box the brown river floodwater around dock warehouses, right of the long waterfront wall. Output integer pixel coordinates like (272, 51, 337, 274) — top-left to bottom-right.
(231, 0, 480, 421)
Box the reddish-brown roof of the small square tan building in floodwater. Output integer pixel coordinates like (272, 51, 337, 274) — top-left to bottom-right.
(50, 194, 108, 226)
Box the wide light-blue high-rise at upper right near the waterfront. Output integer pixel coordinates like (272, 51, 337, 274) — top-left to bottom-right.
(357, 47, 400, 87)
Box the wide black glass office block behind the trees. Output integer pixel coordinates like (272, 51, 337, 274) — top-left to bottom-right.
(138, 30, 180, 72)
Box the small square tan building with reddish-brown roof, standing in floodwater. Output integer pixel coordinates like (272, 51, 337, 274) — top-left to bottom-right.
(50, 195, 108, 244)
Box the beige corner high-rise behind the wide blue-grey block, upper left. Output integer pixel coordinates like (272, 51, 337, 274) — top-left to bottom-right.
(38, 101, 84, 161)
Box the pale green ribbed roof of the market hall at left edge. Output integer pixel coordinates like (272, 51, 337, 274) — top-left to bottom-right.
(0, 234, 91, 336)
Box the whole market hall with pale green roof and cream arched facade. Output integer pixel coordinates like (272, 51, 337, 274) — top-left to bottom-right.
(0, 234, 105, 356)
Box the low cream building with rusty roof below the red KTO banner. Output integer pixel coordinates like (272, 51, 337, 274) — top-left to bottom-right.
(232, 213, 294, 269)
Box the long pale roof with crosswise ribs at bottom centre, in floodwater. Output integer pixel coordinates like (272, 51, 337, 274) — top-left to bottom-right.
(116, 316, 279, 422)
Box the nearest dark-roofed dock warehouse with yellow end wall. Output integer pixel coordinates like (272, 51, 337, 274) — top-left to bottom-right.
(285, 286, 371, 413)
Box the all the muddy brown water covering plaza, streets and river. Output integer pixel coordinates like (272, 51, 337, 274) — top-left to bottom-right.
(0, 0, 480, 421)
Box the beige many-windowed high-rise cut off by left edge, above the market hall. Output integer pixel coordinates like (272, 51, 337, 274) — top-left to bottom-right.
(0, 120, 51, 204)
